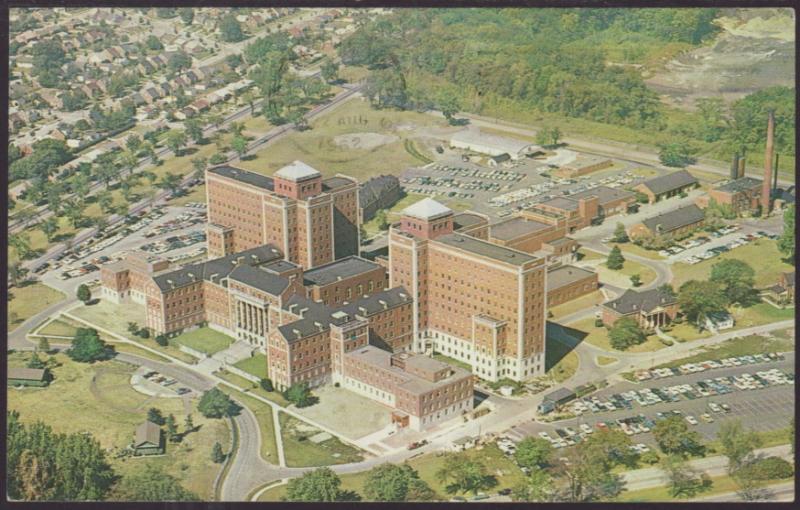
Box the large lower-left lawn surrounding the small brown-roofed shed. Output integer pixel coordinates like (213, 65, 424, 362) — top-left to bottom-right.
(8, 354, 229, 500)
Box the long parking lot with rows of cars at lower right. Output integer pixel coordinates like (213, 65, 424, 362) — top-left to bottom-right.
(506, 353, 794, 446)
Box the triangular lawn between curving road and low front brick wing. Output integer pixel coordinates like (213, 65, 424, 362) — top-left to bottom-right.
(278, 412, 364, 467)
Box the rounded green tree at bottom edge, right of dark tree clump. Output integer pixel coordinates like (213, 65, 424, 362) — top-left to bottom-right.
(110, 464, 200, 502)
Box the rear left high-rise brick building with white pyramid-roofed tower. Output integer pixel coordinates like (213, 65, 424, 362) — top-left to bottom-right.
(206, 161, 360, 269)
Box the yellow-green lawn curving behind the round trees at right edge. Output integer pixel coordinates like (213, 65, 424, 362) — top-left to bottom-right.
(672, 239, 794, 289)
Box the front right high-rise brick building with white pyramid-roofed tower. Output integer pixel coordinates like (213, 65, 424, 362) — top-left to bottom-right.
(388, 198, 546, 381)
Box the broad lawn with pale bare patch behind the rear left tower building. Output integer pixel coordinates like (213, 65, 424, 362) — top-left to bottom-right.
(236, 99, 445, 182)
